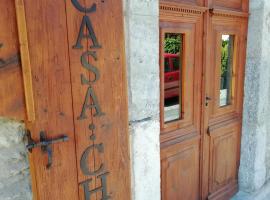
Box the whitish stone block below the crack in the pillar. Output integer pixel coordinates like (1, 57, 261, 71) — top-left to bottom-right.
(130, 120, 160, 200)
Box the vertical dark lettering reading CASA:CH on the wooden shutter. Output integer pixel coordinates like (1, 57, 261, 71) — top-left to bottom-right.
(70, 0, 118, 199)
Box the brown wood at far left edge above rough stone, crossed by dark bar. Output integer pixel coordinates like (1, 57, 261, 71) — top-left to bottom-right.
(0, 1, 26, 120)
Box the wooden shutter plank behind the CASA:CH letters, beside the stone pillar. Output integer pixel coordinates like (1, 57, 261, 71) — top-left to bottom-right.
(66, 0, 131, 199)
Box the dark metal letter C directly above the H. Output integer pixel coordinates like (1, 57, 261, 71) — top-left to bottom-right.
(80, 144, 104, 176)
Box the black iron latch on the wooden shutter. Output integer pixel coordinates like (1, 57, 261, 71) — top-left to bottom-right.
(26, 131, 69, 169)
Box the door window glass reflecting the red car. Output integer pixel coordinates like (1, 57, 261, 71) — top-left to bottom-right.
(163, 33, 183, 123)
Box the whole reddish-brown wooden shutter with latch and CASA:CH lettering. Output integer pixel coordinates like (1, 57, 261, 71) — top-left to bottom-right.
(12, 0, 131, 200)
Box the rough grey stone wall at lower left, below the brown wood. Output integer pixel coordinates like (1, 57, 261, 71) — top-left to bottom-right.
(0, 118, 32, 200)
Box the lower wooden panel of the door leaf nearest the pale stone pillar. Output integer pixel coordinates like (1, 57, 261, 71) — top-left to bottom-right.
(161, 137, 200, 200)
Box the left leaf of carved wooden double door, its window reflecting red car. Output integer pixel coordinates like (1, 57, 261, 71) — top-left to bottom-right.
(160, 3, 203, 200)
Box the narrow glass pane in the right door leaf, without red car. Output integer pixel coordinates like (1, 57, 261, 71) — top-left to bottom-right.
(219, 35, 234, 107)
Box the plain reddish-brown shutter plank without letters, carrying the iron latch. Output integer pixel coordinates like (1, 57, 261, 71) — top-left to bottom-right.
(24, 0, 78, 200)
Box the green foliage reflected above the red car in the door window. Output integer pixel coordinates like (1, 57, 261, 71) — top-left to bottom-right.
(164, 33, 182, 54)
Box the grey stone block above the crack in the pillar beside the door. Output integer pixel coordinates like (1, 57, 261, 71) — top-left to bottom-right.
(126, 15, 159, 121)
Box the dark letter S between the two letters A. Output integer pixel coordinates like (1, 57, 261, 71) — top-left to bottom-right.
(81, 51, 100, 85)
